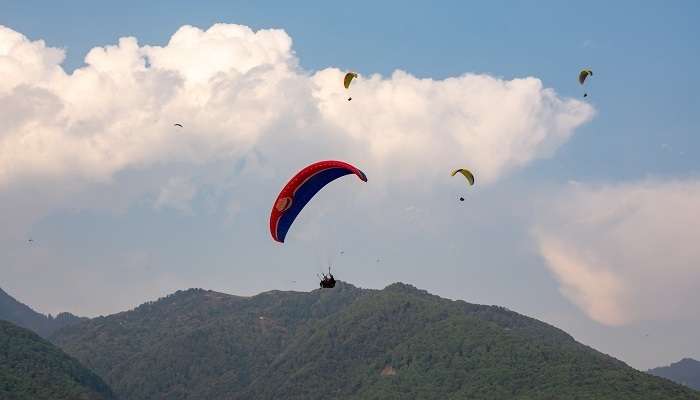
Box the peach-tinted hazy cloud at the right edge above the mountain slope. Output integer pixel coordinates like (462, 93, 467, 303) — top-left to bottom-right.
(535, 180, 700, 325)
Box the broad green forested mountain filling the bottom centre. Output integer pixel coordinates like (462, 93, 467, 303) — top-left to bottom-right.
(52, 282, 700, 400)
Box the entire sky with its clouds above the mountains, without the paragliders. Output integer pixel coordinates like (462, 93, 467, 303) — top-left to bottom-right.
(0, 0, 700, 369)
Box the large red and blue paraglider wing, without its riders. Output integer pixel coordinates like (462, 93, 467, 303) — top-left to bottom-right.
(270, 160, 367, 243)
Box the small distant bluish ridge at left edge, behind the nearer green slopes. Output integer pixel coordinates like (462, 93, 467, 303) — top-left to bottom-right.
(0, 289, 86, 337)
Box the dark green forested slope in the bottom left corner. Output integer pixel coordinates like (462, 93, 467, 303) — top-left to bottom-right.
(0, 321, 114, 400)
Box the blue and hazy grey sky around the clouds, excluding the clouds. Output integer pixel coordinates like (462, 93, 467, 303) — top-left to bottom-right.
(0, 1, 700, 368)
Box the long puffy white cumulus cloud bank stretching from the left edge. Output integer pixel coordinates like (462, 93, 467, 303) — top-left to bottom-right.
(0, 24, 593, 197)
